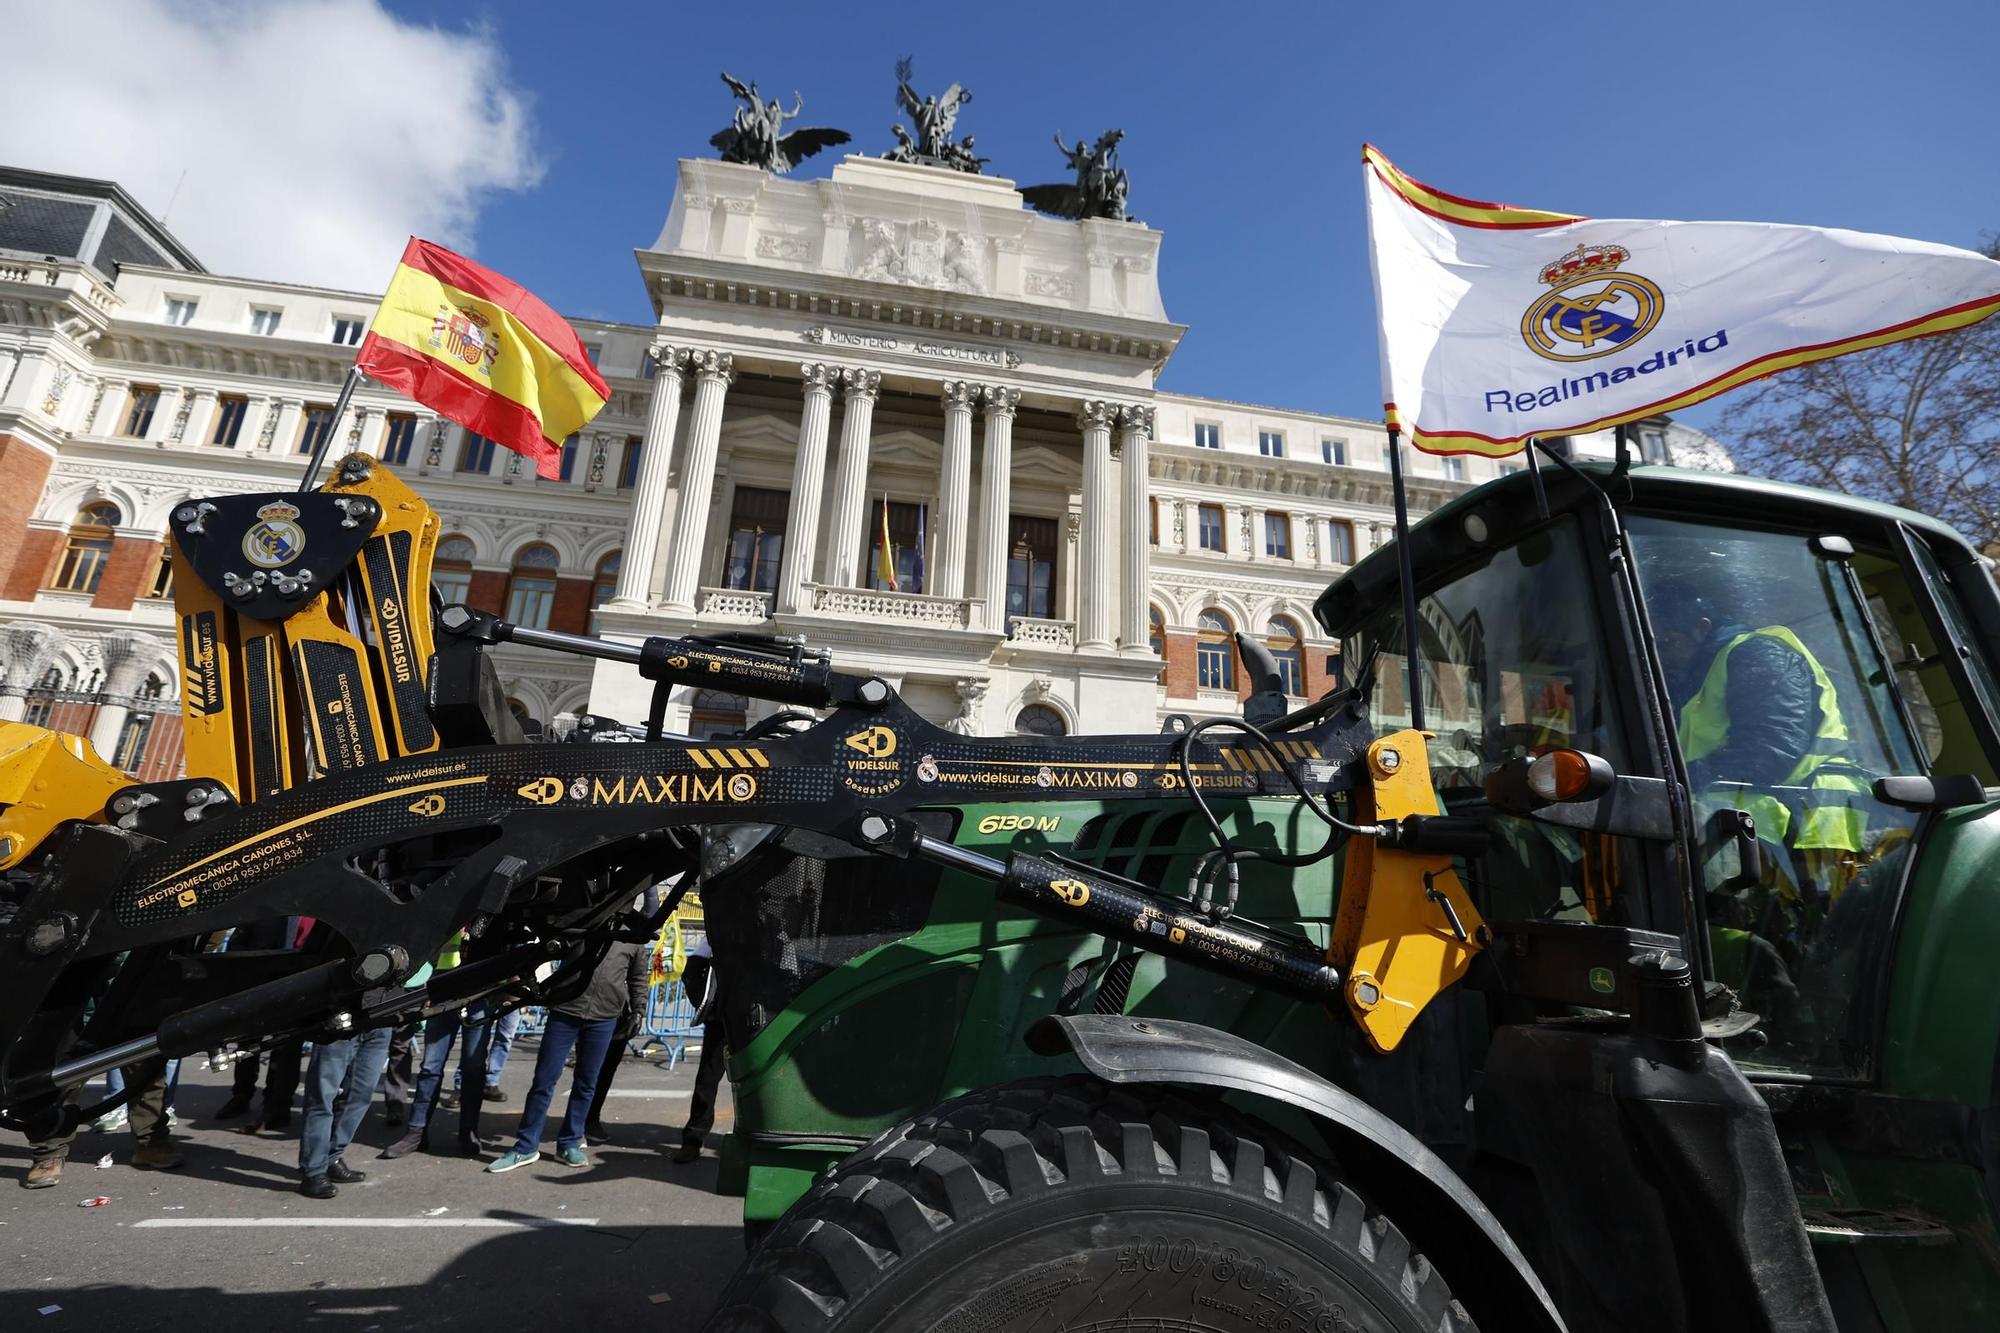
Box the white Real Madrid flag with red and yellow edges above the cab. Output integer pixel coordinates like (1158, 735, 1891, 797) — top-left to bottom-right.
(1362, 146, 2000, 456)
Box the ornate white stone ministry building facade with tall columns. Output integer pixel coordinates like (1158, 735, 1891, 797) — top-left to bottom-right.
(0, 158, 1720, 756)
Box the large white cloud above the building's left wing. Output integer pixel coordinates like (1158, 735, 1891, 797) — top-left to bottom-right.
(0, 0, 542, 290)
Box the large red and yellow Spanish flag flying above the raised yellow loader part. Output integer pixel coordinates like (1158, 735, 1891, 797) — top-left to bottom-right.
(354, 236, 612, 480)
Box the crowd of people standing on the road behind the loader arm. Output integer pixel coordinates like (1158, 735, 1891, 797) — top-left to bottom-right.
(20, 919, 722, 1199)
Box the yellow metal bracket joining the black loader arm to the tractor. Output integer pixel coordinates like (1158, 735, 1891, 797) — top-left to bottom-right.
(1326, 731, 1486, 1051)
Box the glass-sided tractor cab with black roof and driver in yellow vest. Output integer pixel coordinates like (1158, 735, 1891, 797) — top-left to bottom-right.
(1316, 454, 2000, 1327)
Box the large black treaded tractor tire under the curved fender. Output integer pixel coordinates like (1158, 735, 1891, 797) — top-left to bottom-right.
(708, 1075, 1474, 1333)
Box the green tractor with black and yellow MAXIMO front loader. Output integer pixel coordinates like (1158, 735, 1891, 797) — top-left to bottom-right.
(0, 448, 2000, 1331)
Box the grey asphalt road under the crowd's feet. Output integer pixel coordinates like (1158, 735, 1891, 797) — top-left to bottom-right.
(0, 1041, 744, 1333)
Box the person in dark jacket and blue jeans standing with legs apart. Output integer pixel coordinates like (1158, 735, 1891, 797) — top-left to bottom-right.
(486, 941, 652, 1171)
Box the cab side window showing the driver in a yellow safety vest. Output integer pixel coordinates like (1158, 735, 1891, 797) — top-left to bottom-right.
(1628, 514, 1976, 1077)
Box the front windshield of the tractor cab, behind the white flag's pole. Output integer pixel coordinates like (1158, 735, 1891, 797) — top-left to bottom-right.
(1342, 518, 1644, 925)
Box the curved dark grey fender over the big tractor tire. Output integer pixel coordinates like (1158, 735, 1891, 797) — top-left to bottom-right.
(1028, 1015, 1566, 1331)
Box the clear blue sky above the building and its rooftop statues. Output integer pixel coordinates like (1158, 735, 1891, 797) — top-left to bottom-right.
(320, 0, 2000, 420)
